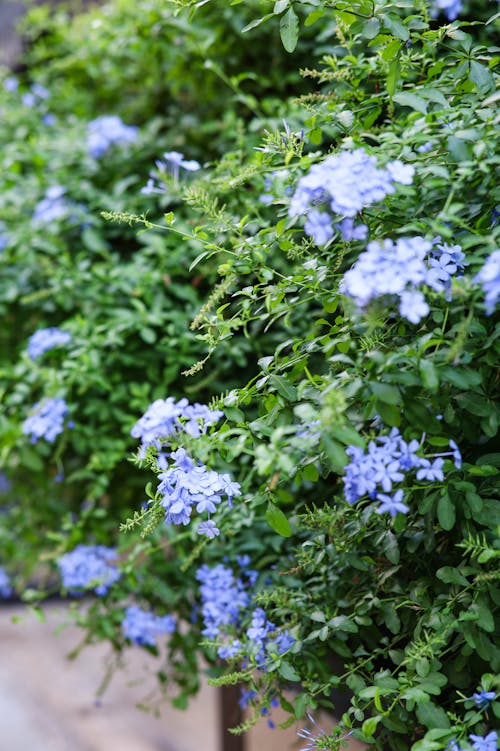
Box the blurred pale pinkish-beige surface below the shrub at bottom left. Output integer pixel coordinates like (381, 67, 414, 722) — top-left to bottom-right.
(0, 605, 368, 751)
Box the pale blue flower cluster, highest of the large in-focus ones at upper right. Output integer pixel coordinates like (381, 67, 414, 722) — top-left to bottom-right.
(289, 149, 414, 245)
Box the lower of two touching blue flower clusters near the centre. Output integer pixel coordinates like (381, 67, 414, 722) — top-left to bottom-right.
(158, 448, 241, 538)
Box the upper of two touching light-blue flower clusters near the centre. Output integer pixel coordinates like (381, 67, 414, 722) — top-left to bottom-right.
(131, 396, 224, 457)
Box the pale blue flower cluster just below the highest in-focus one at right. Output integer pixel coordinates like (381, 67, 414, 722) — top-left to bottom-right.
(341, 236, 465, 323)
